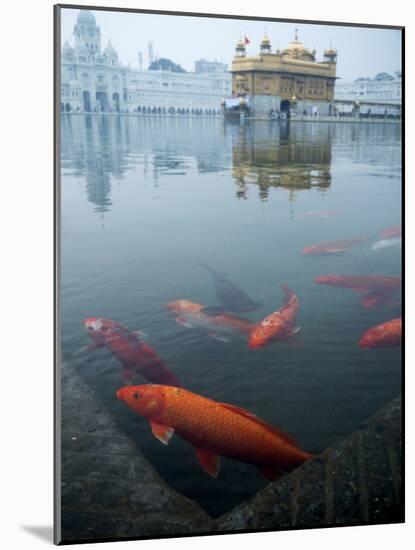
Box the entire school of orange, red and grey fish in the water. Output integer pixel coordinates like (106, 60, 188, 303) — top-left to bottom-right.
(76, 222, 402, 486)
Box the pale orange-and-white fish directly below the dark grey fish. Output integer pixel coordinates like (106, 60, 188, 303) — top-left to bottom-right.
(166, 300, 255, 342)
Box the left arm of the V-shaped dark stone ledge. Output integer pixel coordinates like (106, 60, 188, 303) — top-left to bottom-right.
(59, 365, 212, 543)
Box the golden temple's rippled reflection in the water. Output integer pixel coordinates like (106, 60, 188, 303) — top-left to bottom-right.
(227, 122, 331, 200)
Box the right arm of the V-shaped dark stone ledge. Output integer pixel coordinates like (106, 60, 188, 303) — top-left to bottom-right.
(215, 399, 404, 531)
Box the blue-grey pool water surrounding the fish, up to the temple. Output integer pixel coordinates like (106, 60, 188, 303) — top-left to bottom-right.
(61, 115, 401, 516)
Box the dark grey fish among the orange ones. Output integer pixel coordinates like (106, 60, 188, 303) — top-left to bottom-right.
(198, 262, 262, 315)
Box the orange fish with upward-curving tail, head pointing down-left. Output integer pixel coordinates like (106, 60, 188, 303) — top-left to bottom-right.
(248, 285, 300, 349)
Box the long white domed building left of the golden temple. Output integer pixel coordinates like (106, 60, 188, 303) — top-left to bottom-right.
(61, 9, 231, 115)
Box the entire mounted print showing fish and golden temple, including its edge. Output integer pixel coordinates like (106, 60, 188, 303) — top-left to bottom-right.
(55, 5, 404, 544)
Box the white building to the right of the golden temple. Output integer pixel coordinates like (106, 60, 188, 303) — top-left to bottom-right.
(334, 72, 402, 105)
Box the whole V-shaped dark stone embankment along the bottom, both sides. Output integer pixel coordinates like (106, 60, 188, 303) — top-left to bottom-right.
(58, 365, 403, 542)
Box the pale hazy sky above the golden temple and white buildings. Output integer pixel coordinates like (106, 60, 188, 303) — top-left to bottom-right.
(62, 9, 401, 80)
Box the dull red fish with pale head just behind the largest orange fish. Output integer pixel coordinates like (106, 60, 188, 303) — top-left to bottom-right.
(84, 317, 181, 387)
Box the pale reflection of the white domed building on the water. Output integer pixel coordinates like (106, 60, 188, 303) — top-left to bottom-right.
(61, 115, 231, 213)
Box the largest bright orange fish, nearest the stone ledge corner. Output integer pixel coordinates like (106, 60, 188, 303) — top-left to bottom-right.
(117, 384, 312, 480)
